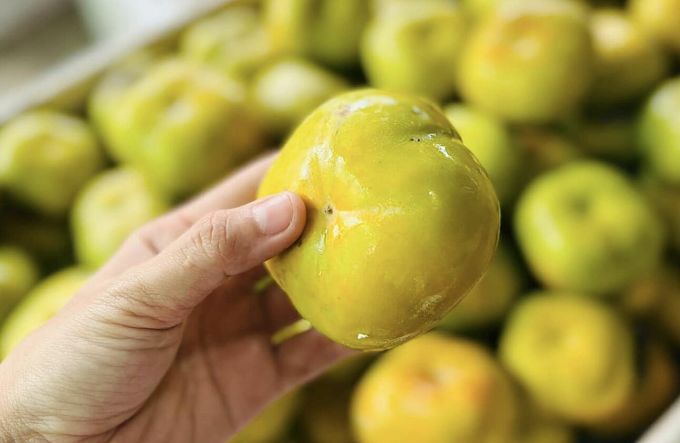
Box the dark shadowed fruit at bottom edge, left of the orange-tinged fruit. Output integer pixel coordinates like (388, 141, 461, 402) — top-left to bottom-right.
(300, 381, 355, 443)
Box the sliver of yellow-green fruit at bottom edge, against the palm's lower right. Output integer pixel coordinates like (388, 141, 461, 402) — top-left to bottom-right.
(229, 391, 302, 443)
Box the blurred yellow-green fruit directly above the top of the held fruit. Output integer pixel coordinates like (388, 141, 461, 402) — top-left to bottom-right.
(361, 1, 467, 100)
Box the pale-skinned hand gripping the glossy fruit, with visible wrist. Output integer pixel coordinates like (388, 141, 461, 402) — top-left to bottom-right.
(0, 155, 349, 443)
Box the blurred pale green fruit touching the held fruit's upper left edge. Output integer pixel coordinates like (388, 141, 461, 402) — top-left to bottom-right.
(250, 58, 349, 136)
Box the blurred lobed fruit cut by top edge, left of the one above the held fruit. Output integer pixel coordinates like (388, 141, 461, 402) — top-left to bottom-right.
(264, 0, 369, 69)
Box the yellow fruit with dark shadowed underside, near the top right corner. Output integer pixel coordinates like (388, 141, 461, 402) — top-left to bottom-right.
(589, 8, 670, 106)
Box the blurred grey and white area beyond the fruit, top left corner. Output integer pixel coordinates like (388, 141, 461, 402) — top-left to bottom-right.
(0, 0, 214, 96)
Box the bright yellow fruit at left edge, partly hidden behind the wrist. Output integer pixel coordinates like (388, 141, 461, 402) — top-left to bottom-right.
(0, 267, 90, 359)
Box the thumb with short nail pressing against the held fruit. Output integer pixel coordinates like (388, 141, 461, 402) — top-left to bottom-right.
(101, 192, 306, 328)
